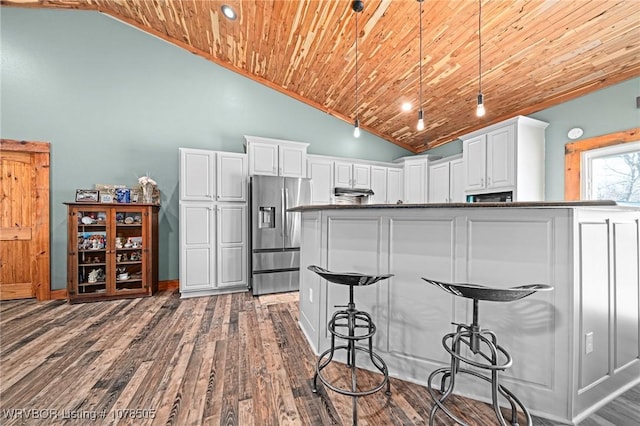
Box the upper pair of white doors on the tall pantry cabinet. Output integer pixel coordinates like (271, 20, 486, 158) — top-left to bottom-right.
(180, 148, 247, 201)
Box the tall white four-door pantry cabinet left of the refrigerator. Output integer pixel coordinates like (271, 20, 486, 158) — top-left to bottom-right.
(180, 148, 248, 298)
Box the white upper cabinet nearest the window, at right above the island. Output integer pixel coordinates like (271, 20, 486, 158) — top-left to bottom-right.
(460, 116, 548, 201)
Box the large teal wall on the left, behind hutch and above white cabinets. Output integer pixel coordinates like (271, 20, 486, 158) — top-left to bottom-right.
(0, 7, 411, 289)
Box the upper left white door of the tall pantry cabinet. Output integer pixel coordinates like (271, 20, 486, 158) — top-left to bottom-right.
(180, 148, 216, 201)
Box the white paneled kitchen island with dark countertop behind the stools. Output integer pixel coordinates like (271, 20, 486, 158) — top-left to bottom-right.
(292, 202, 640, 424)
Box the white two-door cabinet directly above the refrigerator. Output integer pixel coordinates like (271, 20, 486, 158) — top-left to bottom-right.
(245, 136, 309, 177)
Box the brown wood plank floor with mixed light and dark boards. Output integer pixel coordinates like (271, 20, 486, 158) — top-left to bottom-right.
(0, 292, 640, 426)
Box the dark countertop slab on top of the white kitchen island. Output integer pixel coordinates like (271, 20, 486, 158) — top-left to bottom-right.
(288, 200, 640, 212)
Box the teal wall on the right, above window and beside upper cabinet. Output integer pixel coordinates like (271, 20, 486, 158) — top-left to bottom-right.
(426, 78, 640, 201)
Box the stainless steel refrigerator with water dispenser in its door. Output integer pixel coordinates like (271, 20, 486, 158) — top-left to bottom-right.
(251, 176, 311, 295)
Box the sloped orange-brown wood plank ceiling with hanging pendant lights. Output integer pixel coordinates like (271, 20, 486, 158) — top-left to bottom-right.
(1, 0, 640, 153)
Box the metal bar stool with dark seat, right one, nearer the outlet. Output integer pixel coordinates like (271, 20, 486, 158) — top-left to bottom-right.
(422, 278, 553, 426)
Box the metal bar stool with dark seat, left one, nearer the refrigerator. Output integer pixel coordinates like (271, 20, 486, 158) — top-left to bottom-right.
(307, 265, 393, 425)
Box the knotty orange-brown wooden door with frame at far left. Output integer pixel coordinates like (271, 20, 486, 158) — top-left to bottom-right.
(0, 139, 51, 300)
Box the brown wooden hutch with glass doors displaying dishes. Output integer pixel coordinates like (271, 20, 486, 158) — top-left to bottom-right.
(65, 203, 160, 303)
